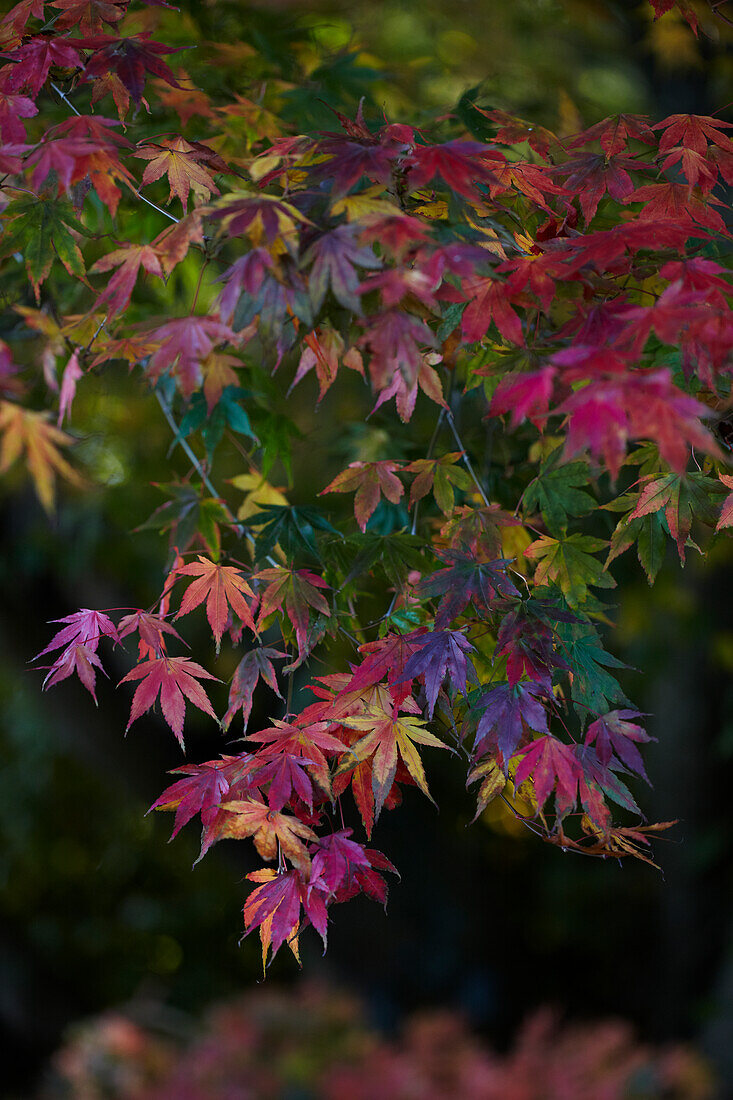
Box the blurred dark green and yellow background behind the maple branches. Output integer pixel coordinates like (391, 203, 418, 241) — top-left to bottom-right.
(0, 0, 733, 1095)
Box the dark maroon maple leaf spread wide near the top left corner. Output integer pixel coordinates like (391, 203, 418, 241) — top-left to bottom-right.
(71, 32, 184, 107)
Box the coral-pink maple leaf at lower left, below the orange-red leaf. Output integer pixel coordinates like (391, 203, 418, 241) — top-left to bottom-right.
(120, 656, 219, 748)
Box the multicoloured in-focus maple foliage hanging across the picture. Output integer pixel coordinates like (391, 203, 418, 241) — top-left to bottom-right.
(0, 0, 733, 961)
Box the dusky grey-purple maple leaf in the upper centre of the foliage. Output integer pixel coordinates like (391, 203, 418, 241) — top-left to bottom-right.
(303, 226, 382, 314)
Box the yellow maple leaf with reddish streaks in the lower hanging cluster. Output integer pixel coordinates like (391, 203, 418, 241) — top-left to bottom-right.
(335, 708, 448, 817)
